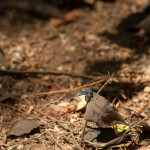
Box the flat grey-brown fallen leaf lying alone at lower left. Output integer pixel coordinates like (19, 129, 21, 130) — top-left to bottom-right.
(7, 119, 45, 137)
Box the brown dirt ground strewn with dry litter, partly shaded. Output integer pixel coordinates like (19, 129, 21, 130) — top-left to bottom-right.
(0, 0, 150, 150)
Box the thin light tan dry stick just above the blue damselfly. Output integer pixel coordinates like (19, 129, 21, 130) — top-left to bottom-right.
(35, 78, 107, 95)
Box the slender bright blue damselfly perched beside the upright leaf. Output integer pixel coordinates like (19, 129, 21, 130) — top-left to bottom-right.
(46, 90, 92, 106)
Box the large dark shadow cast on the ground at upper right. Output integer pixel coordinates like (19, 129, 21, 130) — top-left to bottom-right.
(88, 6, 150, 75)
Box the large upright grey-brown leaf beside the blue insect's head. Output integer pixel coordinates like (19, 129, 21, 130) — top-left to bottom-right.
(84, 92, 127, 128)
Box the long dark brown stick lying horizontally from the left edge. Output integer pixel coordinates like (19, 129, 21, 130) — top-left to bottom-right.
(0, 70, 98, 79)
